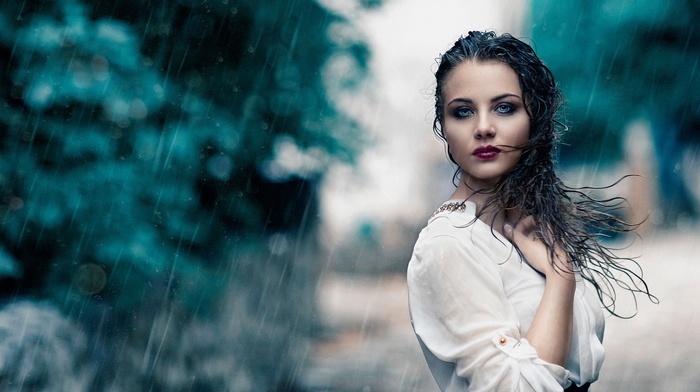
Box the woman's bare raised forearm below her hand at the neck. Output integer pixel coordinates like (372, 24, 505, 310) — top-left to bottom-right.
(525, 270, 576, 366)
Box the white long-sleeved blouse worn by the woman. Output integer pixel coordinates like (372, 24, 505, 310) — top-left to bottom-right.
(407, 202, 605, 391)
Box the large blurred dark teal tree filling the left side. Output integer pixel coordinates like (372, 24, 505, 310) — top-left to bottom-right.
(0, 0, 377, 390)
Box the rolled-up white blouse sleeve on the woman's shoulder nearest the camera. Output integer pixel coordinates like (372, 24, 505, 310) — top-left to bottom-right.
(408, 222, 570, 391)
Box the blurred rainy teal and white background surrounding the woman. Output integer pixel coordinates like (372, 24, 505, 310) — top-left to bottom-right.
(0, 0, 700, 391)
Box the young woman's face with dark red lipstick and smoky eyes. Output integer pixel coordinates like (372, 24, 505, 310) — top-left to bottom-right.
(442, 60, 530, 190)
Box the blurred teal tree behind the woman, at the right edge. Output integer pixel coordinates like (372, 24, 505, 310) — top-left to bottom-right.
(532, 0, 700, 223)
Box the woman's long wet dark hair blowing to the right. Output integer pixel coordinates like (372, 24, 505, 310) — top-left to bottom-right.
(433, 31, 658, 316)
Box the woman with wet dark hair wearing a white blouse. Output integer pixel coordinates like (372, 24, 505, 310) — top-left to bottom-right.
(408, 32, 649, 391)
